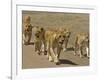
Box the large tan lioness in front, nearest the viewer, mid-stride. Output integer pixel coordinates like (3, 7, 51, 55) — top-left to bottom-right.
(45, 30, 66, 65)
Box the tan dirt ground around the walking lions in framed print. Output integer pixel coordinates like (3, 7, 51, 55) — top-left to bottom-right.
(22, 11, 89, 69)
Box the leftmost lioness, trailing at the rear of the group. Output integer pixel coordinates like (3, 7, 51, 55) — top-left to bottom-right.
(23, 16, 33, 45)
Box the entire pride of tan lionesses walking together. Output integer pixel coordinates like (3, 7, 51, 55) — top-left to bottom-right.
(23, 16, 89, 65)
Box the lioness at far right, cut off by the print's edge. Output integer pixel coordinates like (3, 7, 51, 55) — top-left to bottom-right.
(74, 33, 89, 57)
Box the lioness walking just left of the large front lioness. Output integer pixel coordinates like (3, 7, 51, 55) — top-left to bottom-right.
(33, 26, 46, 55)
